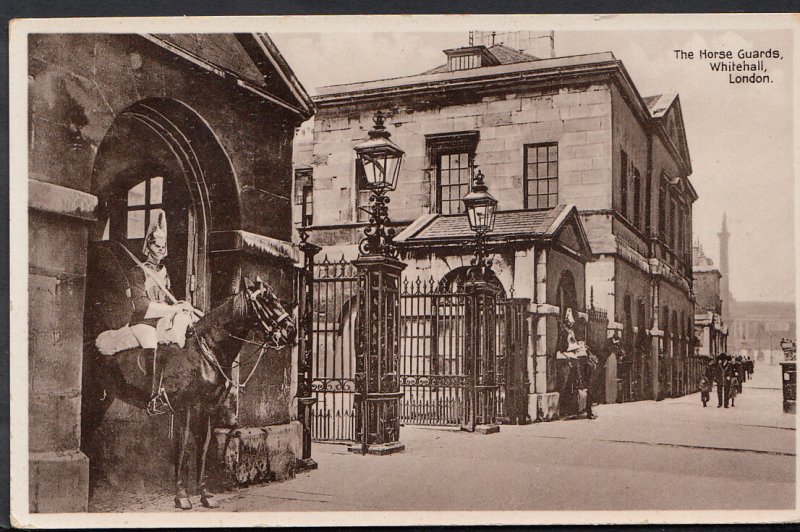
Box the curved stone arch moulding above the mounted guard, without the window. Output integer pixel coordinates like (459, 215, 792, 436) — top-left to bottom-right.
(90, 98, 241, 308)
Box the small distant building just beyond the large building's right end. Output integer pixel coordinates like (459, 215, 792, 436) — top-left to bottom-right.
(692, 243, 728, 358)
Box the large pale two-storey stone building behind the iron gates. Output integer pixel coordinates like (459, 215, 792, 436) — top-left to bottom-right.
(295, 40, 697, 412)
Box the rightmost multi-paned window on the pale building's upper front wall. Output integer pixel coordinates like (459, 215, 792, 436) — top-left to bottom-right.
(524, 142, 558, 209)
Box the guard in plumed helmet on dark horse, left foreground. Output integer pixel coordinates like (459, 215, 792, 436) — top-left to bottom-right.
(81, 214, 297, 510)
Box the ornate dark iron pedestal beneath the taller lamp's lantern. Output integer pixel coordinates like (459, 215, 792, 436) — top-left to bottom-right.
(349, 255, 406, 455)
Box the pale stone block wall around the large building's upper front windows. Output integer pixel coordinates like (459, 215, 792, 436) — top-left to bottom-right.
(295, 85, 611, 237)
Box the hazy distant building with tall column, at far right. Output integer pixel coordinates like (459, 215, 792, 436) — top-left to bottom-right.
(719, 216, 797, 362)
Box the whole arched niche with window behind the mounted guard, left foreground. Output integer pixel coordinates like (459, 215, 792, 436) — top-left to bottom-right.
(81, 98, 241, 491)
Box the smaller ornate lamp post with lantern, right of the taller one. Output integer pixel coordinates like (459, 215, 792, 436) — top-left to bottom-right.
(461, 170, 500, 434)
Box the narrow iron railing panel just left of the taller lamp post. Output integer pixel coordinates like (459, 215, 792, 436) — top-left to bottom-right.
(311, 256, 358, 442)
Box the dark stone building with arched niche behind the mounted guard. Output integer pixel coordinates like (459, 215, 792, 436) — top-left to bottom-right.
(28, 34, 313, 512)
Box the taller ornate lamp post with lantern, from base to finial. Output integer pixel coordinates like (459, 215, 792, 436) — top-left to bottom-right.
(349, 111, 406, 455)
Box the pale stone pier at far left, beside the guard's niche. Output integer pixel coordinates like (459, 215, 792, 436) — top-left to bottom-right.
(28, 180, 97, 513)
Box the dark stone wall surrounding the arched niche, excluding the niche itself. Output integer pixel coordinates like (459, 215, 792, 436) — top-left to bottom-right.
(28, 34, 299, 512)
